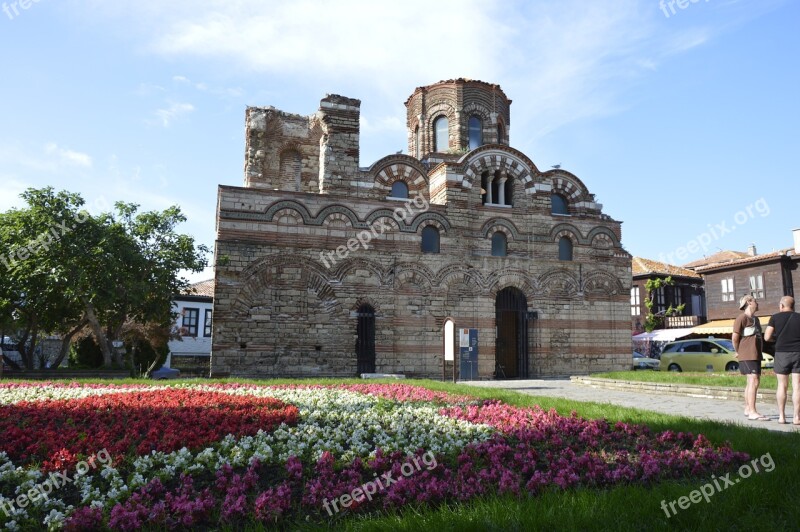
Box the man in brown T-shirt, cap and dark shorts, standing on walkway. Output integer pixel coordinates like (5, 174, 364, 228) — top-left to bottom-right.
(731, 295, 769, 421)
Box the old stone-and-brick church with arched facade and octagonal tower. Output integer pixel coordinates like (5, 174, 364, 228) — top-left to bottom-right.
(211, 79, 631, 379)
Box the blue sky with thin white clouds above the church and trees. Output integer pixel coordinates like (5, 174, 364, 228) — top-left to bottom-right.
(0, 0, 800, 279)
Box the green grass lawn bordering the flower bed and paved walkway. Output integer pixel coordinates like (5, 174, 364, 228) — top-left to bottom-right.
(3, 372, 800, 532)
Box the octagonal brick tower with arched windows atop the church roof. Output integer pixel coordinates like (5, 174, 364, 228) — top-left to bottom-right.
(406, 78, 511, 160)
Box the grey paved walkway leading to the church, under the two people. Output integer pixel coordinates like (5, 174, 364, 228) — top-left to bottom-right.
(459, 379, 800, 432)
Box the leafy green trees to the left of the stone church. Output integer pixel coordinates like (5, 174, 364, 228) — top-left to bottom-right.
(0, 187, 208, 368)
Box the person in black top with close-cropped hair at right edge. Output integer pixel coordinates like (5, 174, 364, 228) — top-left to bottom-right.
(764, 296, 800, 425)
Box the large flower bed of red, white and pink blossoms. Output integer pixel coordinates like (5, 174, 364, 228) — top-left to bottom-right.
(0, 383, 748, 530)
